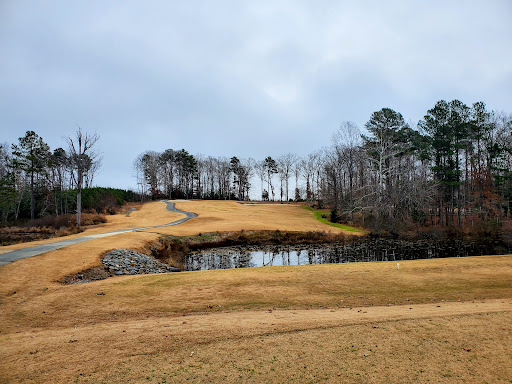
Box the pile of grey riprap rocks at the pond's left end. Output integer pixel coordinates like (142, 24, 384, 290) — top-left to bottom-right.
(102, 249, 180, 275)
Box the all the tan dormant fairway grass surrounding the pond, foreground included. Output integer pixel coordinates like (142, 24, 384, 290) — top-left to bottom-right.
(0, 201, 512, 383)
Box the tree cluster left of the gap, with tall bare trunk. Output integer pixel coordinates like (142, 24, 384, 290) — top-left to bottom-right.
(0, 128, 128, 226)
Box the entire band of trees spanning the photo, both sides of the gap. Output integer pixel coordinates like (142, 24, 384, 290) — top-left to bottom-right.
(0, 100, 512, 233)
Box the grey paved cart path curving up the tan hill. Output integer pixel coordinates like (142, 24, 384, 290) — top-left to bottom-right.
(0, 200, 197, 266)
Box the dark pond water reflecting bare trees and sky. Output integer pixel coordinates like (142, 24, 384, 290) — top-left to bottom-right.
(184, 239, 484, 271)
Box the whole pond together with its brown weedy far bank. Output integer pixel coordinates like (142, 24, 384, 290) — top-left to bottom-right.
(65, 231, 512, 283)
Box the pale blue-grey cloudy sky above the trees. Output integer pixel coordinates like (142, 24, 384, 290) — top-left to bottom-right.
(0, 0, 512, 189)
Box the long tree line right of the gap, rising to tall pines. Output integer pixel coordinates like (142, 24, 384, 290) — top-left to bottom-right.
(134, 100, 512, 232)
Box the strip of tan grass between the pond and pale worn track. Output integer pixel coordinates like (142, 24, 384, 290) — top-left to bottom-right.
(0, 256, 512, 329)
